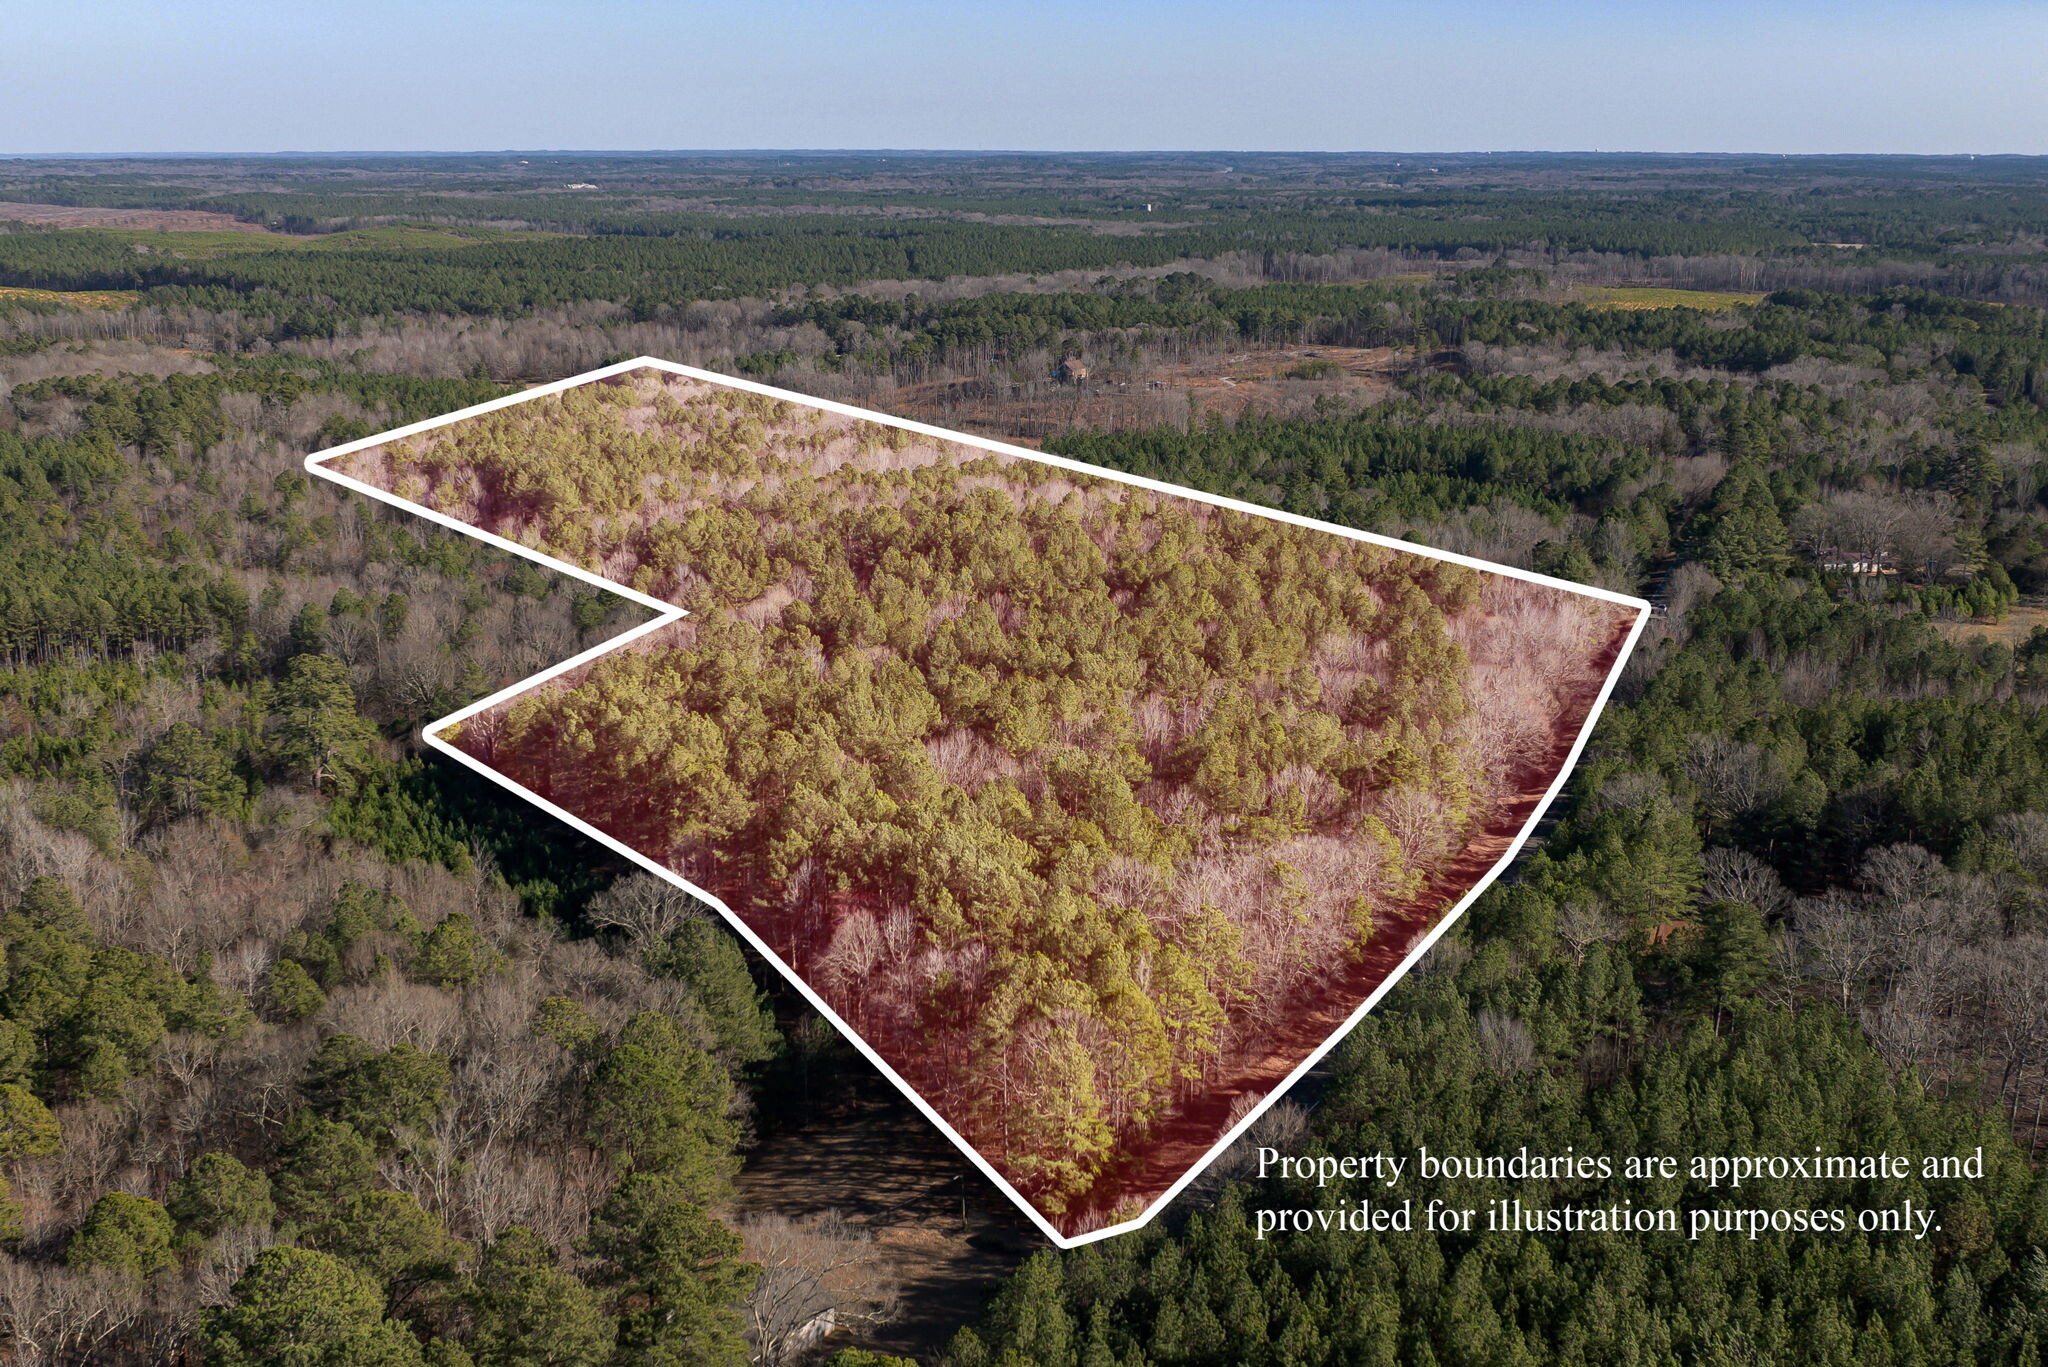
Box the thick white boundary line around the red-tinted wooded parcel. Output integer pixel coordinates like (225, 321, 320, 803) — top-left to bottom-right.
(305, 357, 1651, 1248)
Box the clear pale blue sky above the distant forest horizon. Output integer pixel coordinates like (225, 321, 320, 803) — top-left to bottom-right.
(0, 0, 2048, 154)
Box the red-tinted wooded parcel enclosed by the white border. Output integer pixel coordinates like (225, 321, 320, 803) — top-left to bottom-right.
(311, 363, 1647, 1244)
